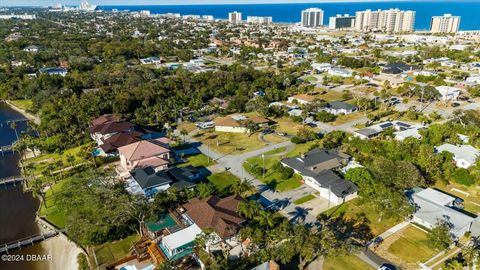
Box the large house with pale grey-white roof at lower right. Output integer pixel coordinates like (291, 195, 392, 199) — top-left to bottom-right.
(407, 188, 476, 239)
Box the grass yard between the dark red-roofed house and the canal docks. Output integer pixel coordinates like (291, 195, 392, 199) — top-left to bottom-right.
(25, 143, 86, 175)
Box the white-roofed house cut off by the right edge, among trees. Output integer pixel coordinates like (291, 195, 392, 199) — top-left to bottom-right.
(435, 143, 480, 169)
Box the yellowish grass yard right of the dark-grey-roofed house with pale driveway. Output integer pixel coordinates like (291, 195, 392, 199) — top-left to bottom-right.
(323, 198, 399, 236)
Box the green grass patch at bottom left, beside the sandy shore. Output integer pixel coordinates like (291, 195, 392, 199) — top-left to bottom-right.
(94, 234, 140, 265)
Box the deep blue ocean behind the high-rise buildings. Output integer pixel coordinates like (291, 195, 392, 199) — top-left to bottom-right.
(99, 0, 480, 30)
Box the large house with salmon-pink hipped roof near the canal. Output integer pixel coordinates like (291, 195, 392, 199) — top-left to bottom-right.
(118, 139, 170, 171)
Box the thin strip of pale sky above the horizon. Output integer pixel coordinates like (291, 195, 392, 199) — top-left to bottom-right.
(0, 0, 424, 6)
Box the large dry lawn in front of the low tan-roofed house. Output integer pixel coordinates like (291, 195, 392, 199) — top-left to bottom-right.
(191, 131, 267, 154)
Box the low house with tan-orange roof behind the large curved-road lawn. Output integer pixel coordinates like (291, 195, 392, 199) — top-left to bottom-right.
(214, 115, 270, 133)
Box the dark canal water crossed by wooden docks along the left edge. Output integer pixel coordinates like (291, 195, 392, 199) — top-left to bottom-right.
(0, 102, 48, 270)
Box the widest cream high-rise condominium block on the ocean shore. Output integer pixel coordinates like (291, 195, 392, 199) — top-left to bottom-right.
(355, 9, 415, 33)
